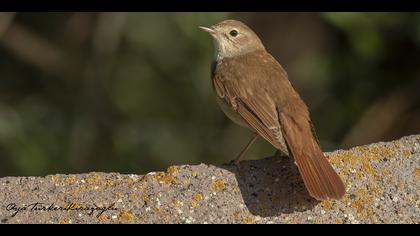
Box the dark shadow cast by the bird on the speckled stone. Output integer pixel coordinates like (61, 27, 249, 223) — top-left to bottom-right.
(222, 157, 319, 217)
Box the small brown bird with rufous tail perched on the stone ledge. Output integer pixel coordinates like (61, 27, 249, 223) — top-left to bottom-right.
(200, 20, 345, 200)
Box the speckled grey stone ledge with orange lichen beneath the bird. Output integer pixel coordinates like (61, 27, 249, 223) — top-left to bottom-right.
(0, 135, 420, 223)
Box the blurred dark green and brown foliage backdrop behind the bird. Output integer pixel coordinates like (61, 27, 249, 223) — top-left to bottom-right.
(0, 13, 420, 176)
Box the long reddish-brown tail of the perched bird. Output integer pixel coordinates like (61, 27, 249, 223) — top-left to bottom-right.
(280, 114, 346, 200)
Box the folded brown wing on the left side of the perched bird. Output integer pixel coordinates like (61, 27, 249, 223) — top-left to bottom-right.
(213, 52, 284, 150)
